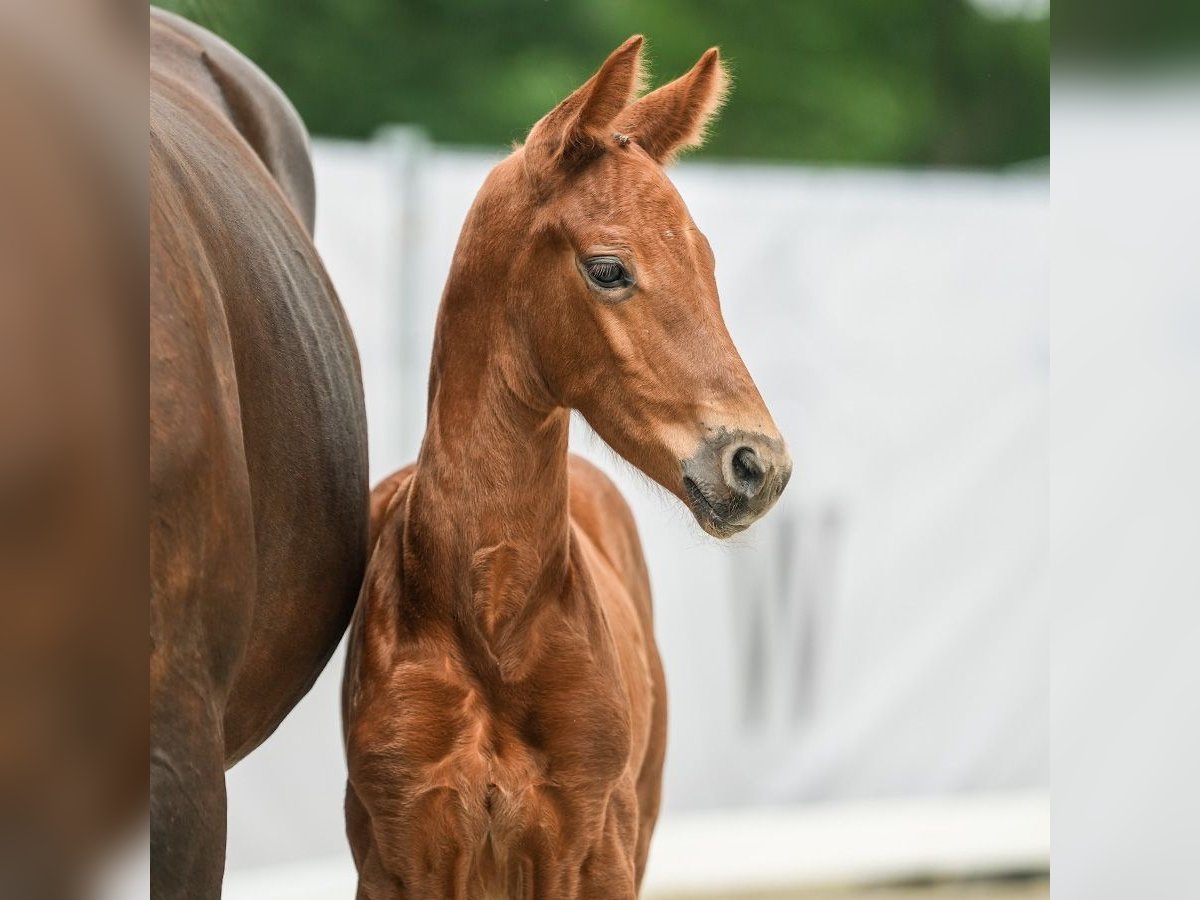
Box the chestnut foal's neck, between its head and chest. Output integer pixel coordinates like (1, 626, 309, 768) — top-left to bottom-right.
(406, 239, 570, 668)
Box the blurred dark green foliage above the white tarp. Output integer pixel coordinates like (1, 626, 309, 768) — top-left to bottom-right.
(162, 0, 1050, 167)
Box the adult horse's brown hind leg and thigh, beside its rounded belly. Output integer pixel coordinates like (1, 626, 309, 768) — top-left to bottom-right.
(150, 211, 256, 898)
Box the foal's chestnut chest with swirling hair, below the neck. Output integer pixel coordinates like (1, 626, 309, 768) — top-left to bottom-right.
(350, 624, 635, 877)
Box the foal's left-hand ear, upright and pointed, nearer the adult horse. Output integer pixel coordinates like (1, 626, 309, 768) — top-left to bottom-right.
(524, 35, 642, 187)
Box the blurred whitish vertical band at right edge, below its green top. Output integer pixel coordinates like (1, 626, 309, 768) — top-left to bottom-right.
(1050, 68, 1200, 900)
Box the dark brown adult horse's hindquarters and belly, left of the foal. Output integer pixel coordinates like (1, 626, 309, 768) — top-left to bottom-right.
(150, 10, 368, 898)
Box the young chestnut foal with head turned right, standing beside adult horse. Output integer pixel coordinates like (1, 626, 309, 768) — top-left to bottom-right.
(343, 37, 791, 900)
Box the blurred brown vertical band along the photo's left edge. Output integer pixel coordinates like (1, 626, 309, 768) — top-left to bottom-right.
(0, 2, 148, 899)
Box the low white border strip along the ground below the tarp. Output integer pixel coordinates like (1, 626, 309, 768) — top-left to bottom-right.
(224, 792, 1050, 900)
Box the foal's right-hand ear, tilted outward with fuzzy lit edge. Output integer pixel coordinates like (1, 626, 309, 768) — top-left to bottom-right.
(617, 47, 730, 163)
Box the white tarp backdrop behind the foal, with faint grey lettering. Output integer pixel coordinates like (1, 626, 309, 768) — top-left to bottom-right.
(220, 137, 1049, 869)
